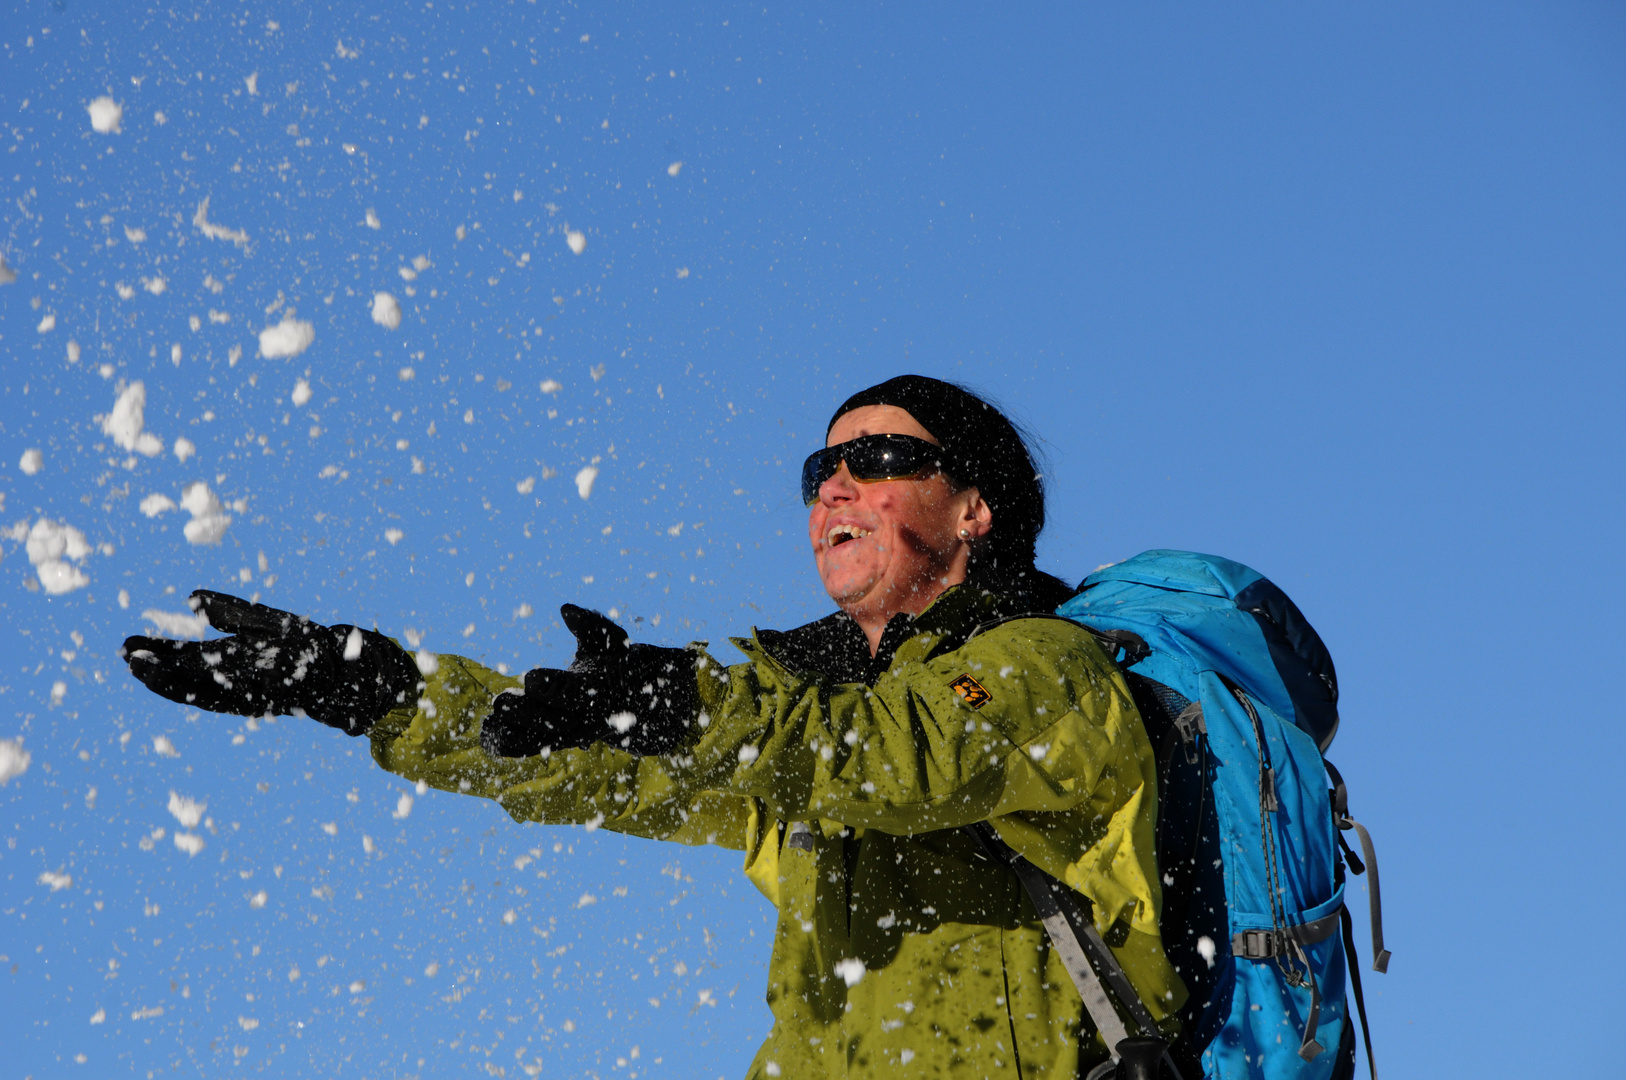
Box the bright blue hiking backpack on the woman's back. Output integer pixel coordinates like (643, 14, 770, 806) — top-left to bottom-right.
(1057, 550, 1389, 1080)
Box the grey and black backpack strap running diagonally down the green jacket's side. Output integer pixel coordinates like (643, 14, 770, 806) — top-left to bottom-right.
(966, 821, 1179, 1080)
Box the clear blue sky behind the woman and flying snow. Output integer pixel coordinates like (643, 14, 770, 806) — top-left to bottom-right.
(0, 0, 1626, 1080)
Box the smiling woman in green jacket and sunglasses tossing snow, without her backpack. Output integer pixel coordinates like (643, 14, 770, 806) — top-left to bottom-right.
(125, 376, 1185, 1078)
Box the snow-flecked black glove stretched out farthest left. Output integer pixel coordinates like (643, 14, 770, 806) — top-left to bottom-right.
(120, 589, 420, 735)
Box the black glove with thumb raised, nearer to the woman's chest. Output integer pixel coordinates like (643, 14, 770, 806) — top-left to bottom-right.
(480, 603, 699, 758)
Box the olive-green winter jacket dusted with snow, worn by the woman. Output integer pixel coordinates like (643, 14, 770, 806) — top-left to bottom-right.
(371, 586, 1185, 1080)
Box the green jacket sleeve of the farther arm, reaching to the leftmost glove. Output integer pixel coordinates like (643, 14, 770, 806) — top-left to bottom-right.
(367, 655, 753, 849)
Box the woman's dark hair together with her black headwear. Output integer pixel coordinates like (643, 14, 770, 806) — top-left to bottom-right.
(824, 376, 1073, 607)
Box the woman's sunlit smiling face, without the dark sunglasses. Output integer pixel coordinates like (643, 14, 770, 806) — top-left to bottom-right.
(808, 405, 992, 623)
